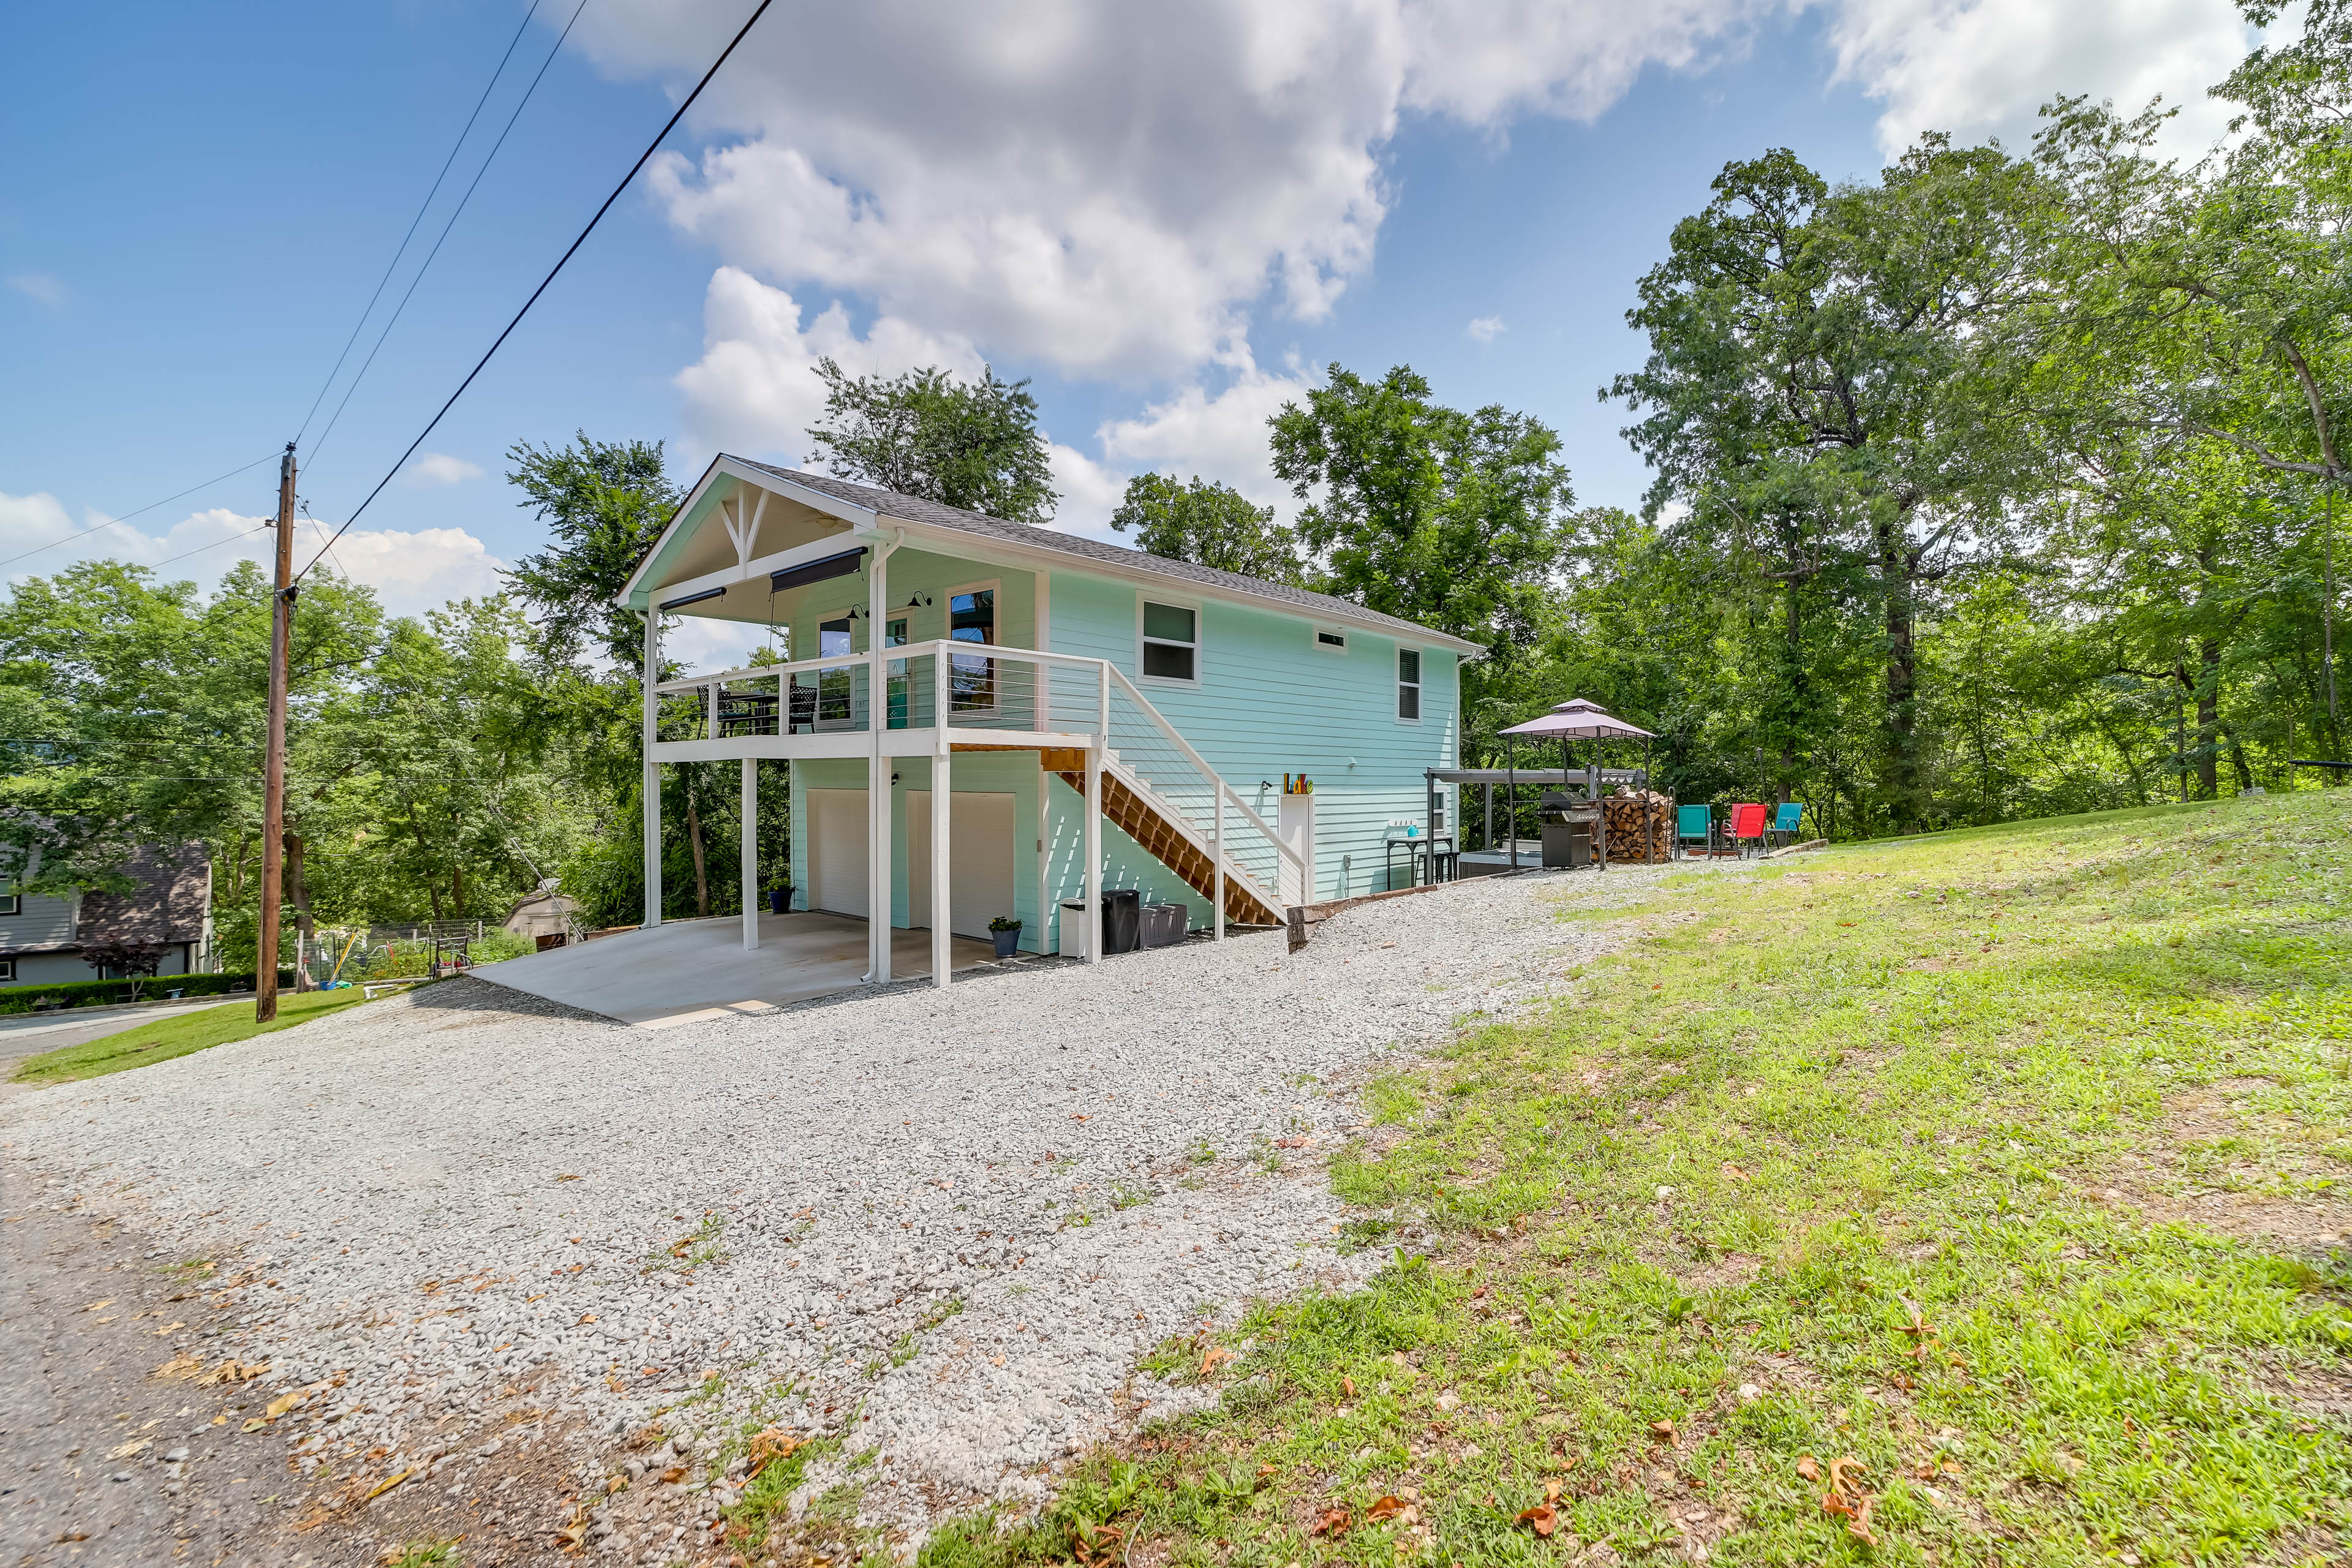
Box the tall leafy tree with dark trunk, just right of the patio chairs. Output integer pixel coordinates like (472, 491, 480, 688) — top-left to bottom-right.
(1604, 137, 2046, 827)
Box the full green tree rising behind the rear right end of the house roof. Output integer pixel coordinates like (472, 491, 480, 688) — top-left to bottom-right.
(1268, 364, 1576, 658)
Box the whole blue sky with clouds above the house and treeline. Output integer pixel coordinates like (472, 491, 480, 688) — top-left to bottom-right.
(0, 0, 2244, 668)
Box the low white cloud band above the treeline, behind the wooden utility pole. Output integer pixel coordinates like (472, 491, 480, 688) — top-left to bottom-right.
(0, 494, 503, 616)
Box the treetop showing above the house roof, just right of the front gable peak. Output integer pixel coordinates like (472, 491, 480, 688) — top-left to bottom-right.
(809, 357, 1061, 522)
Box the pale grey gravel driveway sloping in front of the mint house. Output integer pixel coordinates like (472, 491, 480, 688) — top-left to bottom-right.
(0, 867, 1731, 1561)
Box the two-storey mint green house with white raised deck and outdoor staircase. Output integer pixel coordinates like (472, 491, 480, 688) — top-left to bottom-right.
(621, 456, 1479, 985)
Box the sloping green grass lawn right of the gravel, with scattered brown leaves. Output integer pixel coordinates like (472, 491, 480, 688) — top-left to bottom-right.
(922, 792, 2352, 1568)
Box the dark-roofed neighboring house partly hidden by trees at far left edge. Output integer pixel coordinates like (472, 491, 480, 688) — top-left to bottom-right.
(0, 844, 212, 985)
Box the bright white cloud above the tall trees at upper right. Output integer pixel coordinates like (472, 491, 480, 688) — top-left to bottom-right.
(1830, 0, 2251, 155)
